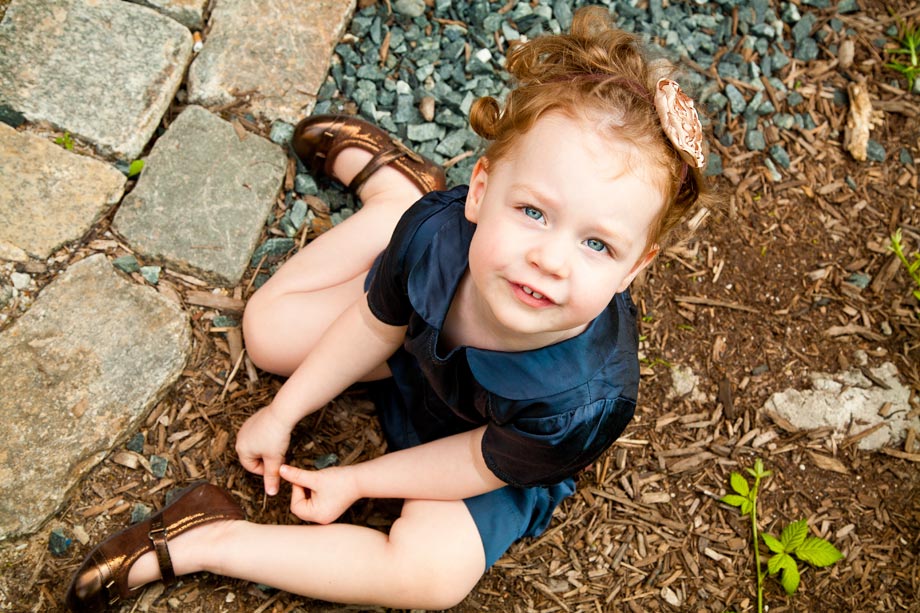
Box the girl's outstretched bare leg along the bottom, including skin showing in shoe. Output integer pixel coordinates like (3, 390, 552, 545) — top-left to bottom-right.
(129, 500, 485, 609)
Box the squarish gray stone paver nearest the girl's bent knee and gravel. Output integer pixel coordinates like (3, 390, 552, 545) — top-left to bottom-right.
(114, 106, 287, 286)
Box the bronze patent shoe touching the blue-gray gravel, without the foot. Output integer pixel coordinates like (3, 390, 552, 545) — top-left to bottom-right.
(291, 115, 447, 194)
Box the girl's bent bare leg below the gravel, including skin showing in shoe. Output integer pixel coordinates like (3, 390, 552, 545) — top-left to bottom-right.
(243, 147, 422, 378)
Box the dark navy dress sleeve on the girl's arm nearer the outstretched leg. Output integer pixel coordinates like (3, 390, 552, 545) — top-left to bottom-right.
(482, 396, 636, 487)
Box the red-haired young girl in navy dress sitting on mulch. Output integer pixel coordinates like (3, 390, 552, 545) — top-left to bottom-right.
(68, 5, 703, 611)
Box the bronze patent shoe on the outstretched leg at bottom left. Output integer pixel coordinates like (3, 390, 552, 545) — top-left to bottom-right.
(67, 482, 245, 613)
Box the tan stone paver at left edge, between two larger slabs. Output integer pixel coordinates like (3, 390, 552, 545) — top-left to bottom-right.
(0, 123, 127, 260)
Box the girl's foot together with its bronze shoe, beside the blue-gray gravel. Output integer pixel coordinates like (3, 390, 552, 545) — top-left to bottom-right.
(291, 115, 446, 199)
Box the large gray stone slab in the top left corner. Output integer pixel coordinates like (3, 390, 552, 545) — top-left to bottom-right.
(0, 0, 192, 160)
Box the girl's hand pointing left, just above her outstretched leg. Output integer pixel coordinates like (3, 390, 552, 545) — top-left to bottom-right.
(281, 464, 360, 524)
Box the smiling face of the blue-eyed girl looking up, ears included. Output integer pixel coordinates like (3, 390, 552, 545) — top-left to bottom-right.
(466, 113, 664, 347)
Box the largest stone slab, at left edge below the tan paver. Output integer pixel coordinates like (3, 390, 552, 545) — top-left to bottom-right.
(0, 255, 191, 540)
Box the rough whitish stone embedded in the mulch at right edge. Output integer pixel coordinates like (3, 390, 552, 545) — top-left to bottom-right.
(764, 362, 920, 450)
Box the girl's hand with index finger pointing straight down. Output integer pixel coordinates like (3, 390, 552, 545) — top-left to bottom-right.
(236, 405, 291, 496)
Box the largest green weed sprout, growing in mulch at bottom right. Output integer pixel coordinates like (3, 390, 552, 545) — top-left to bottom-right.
(721, 458, 843, 613)
